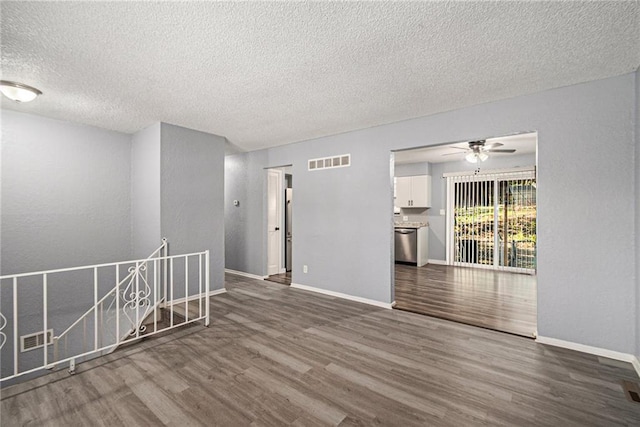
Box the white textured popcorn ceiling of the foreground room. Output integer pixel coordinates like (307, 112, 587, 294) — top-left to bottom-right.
(0, 1, 640, 150)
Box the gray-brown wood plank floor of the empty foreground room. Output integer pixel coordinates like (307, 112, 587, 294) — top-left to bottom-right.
(0, 275, 640, 426)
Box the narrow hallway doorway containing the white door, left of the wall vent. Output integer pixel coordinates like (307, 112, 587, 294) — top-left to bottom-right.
(267, 166, 293, 285)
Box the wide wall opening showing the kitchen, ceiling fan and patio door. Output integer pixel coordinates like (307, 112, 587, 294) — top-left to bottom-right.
(393, 132, 537, 337)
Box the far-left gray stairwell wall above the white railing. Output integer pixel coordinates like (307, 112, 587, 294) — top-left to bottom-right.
(0, 110, 131, 274)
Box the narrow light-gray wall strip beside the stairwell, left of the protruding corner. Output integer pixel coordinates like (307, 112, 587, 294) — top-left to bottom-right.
(131, 123, 163, 259)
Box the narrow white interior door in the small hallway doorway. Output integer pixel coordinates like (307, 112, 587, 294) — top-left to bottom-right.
(267, 169, 283, 276)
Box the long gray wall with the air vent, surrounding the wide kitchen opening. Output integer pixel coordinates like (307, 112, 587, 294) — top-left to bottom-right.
(227, 74, 637, 353)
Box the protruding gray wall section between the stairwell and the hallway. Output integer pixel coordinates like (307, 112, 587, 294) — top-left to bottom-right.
(160, 123, 226, 290)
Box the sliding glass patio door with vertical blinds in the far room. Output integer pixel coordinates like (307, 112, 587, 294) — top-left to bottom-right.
(446, 169, 536, 273)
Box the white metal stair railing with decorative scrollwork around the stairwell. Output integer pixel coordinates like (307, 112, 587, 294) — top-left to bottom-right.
(0, 239, 209, 382)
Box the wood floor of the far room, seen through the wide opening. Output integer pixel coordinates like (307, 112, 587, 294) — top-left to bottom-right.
(395, 264, 537, 338)
